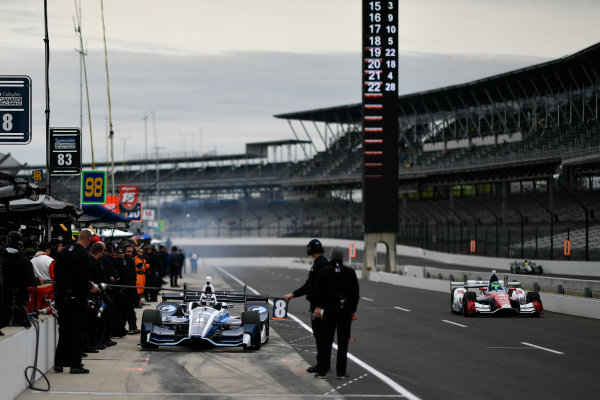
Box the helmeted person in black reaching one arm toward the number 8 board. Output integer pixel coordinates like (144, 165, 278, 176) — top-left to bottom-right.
(283, 239, 329, 372)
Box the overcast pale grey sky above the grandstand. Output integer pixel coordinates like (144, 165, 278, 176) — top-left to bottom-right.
(0, 0, 600, 165)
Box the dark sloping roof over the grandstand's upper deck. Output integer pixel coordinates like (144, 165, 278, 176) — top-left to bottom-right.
(274, 43, 600, 123)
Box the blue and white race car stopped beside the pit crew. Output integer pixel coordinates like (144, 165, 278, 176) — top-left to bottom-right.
(140, 277, 269, 350)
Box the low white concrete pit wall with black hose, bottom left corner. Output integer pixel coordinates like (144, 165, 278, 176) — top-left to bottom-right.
(0, 316, 58, 400)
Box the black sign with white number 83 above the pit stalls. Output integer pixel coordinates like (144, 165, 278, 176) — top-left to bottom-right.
(48, 128, 81, 176)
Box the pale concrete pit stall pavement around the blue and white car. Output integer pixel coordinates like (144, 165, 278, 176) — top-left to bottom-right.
(18, 267, 334, 400)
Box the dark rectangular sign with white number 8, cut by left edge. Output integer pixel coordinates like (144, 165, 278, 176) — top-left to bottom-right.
(0, 75, 31, 144)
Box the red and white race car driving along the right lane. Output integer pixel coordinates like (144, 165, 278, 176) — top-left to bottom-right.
(450, 271, 544, 317)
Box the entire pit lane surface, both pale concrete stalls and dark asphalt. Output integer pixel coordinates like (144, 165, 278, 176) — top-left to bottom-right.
(19, 265, 600, 399)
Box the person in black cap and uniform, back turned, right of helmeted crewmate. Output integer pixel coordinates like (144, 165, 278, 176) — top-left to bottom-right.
(313, 247, 359, 379)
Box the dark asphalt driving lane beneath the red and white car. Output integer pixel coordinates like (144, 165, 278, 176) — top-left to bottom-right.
(223, 266, 600, 399)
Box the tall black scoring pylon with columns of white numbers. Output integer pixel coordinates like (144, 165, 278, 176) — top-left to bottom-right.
(362, 0, 398, 274)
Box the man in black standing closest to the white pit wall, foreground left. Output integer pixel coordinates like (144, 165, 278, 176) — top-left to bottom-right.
(54, 229, 99, 374)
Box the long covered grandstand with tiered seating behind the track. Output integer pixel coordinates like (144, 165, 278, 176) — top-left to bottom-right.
(18, 43, 600, 260)
